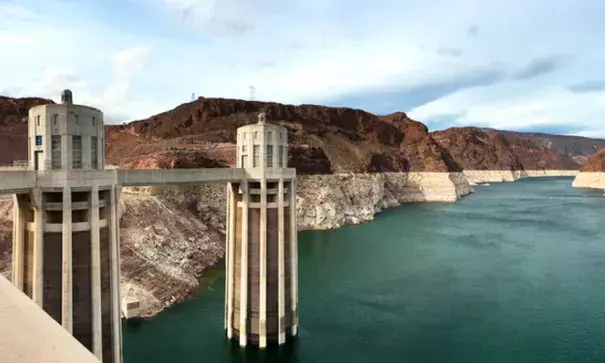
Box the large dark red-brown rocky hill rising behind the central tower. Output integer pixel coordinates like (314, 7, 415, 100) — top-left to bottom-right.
(107, 98, 460, 174)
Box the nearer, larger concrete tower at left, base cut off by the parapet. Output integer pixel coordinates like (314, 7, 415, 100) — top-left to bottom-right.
(13, 90, 122, 363)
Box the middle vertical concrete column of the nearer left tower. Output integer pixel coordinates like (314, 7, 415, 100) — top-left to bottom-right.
(61, 185, 73, 334)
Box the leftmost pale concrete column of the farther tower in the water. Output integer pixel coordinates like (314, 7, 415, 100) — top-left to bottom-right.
(225, 183, 237, 339)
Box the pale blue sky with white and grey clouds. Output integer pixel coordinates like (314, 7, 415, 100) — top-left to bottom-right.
(0, 0, 605, 137)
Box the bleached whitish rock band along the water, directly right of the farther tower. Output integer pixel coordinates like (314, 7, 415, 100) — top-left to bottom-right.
(296, 172, 472, 229)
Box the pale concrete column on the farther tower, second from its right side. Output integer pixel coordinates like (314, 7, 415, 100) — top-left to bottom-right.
(277, 178, 286, 344)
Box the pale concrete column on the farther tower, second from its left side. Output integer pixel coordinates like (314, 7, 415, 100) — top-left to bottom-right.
(239, 179, 250, 347)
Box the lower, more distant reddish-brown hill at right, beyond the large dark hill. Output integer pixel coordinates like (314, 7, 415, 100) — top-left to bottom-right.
(431, 127, 580, 170)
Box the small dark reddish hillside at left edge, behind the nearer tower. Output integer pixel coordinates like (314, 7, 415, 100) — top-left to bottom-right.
(0, 96, 53, 165)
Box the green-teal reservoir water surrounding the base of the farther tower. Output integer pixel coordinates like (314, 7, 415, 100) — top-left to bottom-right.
(124, 178, 605, 363)
